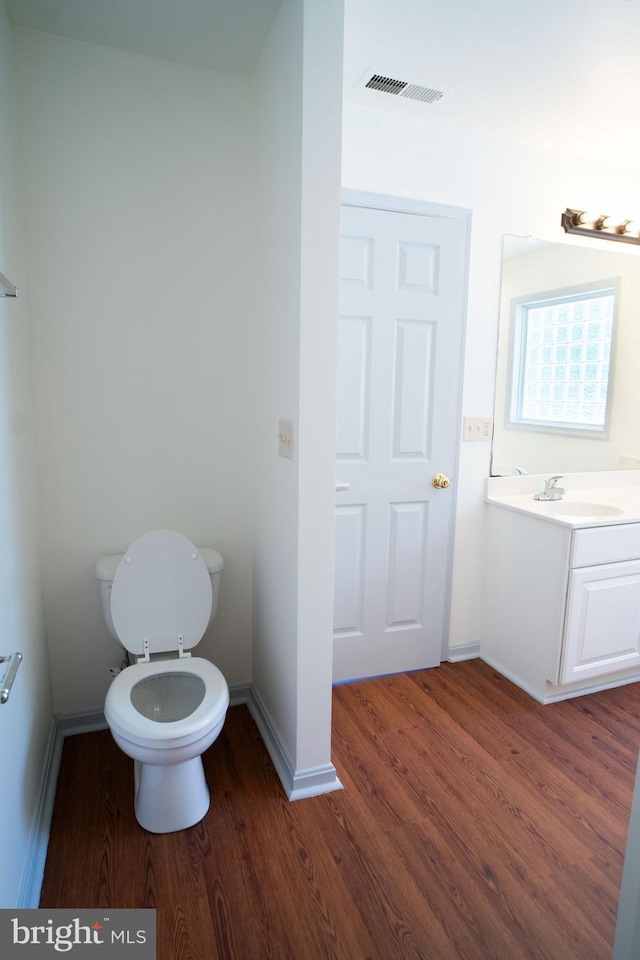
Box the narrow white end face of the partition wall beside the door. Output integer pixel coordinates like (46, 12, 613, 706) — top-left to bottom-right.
(296, 0, 344, 769)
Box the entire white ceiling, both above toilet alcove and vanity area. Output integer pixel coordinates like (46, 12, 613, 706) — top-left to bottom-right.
(5, 0, 640, 162)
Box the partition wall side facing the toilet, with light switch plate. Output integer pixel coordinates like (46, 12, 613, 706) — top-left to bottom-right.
(253, 2, 302, 759)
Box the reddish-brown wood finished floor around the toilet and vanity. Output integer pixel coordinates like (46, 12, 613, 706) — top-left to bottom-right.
(41, 660, 640, 960)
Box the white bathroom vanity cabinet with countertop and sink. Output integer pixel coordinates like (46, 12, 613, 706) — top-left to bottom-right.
(481, 471, 640, 703)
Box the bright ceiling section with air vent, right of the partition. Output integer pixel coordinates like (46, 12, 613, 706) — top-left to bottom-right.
(345, 0, 640, 158)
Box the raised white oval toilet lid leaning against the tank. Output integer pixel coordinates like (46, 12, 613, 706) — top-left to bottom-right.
(111, 530, 212, 655)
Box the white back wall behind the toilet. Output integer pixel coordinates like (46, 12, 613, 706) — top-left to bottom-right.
(16, 30, 254, 713)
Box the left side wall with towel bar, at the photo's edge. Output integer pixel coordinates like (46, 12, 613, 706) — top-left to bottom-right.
(0, 3, 53, 907)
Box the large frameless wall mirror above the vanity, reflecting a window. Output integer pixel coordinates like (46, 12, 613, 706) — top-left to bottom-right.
(491, 236, 640, 476)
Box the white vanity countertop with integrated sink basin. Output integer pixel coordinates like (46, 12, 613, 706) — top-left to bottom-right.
(486, 470, 640, 529)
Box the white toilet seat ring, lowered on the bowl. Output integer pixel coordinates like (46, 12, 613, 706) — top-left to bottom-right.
(104, 657, 229, 748)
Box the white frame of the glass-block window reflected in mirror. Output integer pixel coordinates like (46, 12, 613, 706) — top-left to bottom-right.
(505, 277, 621, 440)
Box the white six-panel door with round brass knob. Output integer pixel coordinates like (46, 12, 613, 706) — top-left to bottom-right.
(334, 194, 469, 680)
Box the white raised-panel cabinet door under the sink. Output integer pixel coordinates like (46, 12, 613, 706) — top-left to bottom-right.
(560, 560, 640, 683)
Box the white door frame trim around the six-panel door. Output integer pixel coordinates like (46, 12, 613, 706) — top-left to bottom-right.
(340, 187, 471, 662)
